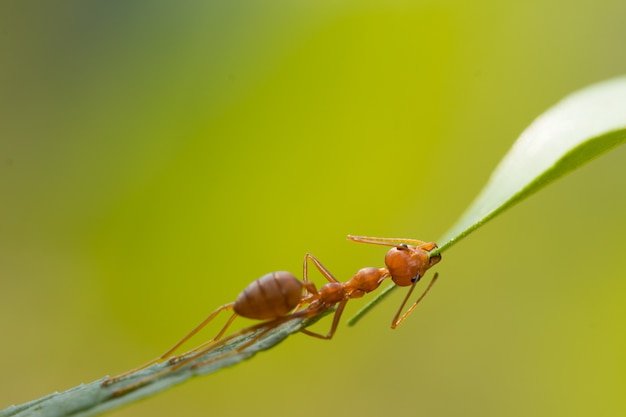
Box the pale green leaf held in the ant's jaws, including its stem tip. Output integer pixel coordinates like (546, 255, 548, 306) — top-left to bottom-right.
(348, 77, 626, 326)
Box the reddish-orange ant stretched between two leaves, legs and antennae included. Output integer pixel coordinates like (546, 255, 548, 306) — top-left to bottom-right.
(102, 235, 441, 396)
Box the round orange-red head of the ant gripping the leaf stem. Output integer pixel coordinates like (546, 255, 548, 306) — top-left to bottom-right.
(385, 245, 441, 287)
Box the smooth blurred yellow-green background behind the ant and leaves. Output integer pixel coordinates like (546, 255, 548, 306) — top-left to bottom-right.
(0, 0, 626, 417)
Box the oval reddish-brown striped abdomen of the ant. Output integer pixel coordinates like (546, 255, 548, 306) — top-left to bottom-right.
(233, 271, 303, 320)
